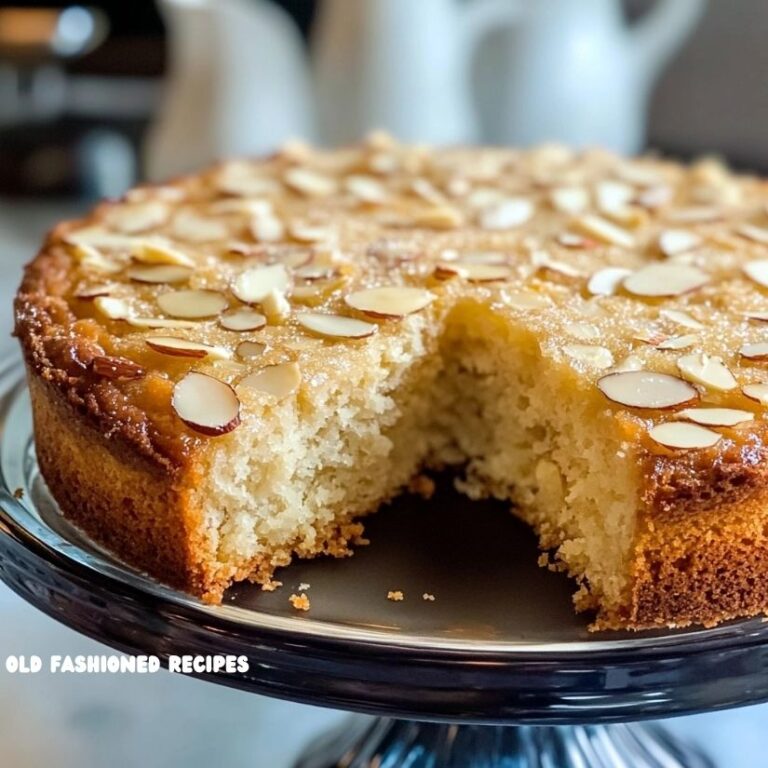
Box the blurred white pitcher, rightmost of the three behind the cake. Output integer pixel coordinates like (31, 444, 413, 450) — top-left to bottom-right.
(476, 0, 704, 153)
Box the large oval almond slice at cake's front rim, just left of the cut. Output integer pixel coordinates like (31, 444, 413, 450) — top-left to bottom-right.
(171, 371, 240, 437)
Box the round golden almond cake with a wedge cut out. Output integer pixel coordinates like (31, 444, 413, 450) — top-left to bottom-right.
(16, 134, 768, 628)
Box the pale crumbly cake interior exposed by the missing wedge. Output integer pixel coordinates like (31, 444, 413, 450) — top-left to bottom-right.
(198, 299, 640, 615)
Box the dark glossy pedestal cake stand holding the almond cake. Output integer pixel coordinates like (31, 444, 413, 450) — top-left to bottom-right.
(0, 356, 768, 768)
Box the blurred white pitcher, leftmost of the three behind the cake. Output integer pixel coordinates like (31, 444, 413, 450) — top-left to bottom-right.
(145, 0, 314, 179)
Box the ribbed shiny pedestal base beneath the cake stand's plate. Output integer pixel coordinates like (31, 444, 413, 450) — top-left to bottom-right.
(294, 717, 714, 768)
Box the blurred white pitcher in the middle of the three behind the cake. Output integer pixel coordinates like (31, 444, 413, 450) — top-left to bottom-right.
(312, 0, 517, 145)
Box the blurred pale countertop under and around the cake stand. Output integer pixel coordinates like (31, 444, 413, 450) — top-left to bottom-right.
(0, 200, 768, 768)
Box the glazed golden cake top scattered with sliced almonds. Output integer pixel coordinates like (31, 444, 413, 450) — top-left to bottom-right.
(19, 135, 768, 452)
